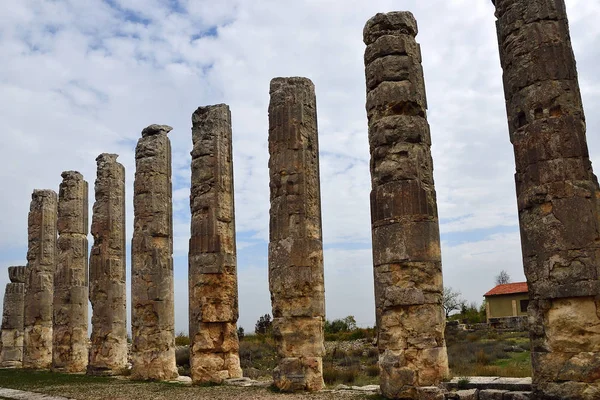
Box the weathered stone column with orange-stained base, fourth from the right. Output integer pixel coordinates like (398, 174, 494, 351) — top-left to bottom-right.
(188, 104, 242, 383)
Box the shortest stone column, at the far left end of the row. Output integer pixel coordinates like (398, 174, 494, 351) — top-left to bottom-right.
(0, 266, 26, 368)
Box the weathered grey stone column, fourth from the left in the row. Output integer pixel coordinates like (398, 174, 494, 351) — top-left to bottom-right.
(87, 153, 127, 375)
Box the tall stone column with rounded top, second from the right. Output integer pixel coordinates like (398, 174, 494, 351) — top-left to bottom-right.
(363, 12, 448, 399)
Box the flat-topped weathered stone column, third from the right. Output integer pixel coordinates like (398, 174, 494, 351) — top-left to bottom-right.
(269, 78, 325, 391)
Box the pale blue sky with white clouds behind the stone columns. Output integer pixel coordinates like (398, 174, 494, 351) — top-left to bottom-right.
(0, 0, 600, 332)
